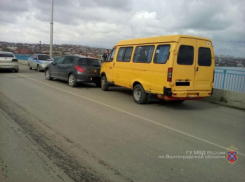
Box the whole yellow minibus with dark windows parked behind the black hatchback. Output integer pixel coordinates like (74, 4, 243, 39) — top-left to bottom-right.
(100, 35, 215, 104)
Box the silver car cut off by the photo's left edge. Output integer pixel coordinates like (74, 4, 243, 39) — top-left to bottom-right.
(0, 51, 19, 73)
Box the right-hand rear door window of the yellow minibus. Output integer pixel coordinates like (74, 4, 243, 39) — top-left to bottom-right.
(198, 47, 212, 66)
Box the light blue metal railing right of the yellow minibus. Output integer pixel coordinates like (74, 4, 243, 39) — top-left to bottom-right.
(214, 68, 245, 92)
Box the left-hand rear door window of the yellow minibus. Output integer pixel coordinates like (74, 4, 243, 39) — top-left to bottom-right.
(177, 45, 194, 65)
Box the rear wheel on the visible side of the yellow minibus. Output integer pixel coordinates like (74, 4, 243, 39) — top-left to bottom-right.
(133, 84, 148, 104)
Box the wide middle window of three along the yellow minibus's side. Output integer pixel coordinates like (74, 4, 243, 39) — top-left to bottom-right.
(133, 46, 155, 63)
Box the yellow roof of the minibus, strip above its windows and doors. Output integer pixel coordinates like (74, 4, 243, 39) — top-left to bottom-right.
(116, 35, 211, 46)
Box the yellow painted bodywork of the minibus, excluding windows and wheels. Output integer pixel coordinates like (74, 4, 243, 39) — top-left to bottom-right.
(101, 35, 214, 98)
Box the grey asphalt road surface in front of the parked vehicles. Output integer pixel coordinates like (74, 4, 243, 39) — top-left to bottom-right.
(0, 66, 245, 182)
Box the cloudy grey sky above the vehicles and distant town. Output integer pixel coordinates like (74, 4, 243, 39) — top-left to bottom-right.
(0, 0, 245, 57)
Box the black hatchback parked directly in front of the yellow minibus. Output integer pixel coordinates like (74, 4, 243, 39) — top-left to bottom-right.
(44, 55, 101, 87)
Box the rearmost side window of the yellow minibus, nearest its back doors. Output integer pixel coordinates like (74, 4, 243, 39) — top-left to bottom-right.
(154, 45, 170, 64)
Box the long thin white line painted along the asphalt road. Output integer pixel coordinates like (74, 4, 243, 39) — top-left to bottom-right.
(18, 74, 245, 156)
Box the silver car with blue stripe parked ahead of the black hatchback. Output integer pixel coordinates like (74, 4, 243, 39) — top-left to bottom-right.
(28, 54, 53, 72)
